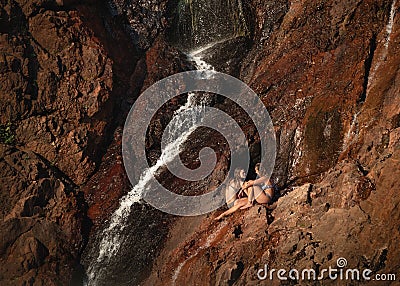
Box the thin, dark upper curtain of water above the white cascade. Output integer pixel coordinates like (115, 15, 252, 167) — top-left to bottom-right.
(170, 0, 248, 52)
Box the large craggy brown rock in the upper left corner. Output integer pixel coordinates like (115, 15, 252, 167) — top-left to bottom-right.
(0, 1, 113, 184)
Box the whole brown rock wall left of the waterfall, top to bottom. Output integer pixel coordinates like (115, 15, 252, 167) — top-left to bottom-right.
(0, 1, 139, 285)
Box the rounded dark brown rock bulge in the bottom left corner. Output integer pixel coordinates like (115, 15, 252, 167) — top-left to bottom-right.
(0, 145, 87, 285)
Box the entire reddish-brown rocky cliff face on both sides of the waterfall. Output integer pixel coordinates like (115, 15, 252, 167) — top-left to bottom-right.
(0, 0, 400, 285)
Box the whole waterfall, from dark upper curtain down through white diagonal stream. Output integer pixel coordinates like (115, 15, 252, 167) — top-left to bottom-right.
(86, 0, 247, 285)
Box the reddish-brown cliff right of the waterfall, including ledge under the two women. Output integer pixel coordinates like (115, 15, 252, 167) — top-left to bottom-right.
(145, 1, 400, 285)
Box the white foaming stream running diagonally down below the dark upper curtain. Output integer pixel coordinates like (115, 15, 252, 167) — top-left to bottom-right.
(86, 45, 214, 285)
